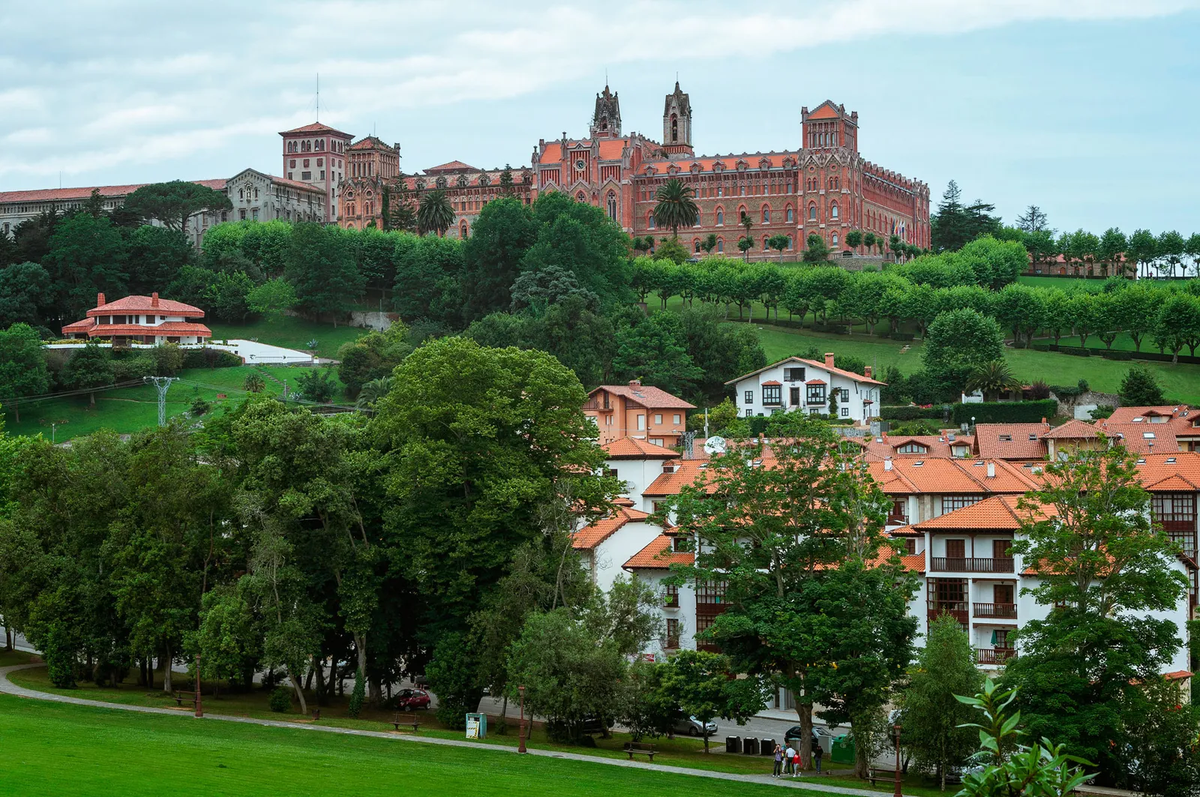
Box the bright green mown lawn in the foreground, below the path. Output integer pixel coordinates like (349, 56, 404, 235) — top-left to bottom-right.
(0, 695, 814, 797)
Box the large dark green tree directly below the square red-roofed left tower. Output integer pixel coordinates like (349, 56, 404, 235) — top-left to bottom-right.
(284, 222, 365, 326)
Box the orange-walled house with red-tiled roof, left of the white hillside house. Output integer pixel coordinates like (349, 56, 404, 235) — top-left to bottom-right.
(583, 379, 696, 448)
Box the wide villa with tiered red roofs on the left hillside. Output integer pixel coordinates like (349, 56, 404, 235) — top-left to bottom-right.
(62, 293, 212, 346)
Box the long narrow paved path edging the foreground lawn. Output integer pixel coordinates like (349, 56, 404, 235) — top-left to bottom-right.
(0, 663, 902, 797)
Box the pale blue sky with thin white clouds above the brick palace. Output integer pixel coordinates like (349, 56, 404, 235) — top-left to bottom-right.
(0, 0, 1200, 235)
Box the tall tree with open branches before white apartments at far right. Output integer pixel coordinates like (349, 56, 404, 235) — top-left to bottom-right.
(1004, 445, 1188, 783)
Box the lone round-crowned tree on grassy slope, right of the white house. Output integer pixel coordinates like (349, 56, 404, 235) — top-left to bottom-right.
(922, 308, 1004, 395)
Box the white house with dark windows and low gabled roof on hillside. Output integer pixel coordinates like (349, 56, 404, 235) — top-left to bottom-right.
(725, 353, 884, 425)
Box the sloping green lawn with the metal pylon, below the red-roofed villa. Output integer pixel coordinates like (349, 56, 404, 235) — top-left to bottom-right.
(2, 365, 338, 443)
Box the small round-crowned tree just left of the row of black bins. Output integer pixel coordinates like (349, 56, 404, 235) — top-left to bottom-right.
(661, 651, 767, 753)
